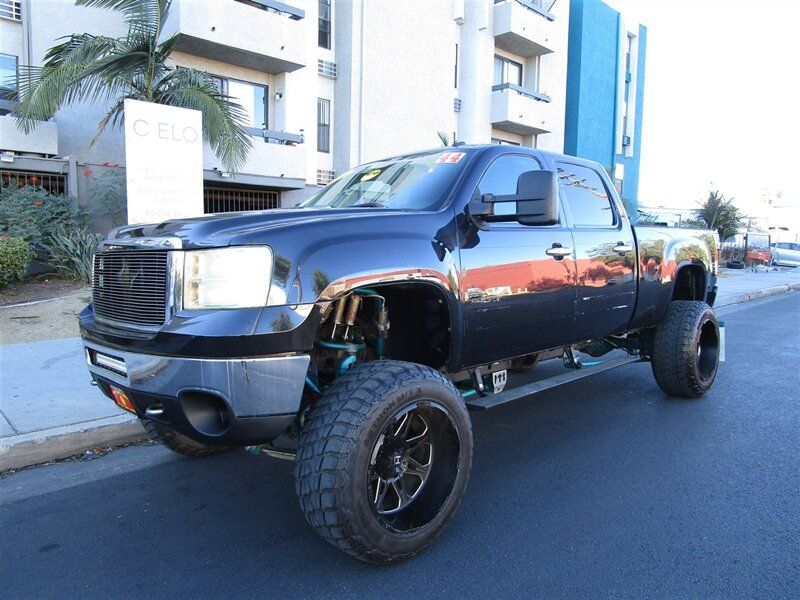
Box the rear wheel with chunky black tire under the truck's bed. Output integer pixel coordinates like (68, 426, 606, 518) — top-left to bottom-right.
(652, 300, 720, 398)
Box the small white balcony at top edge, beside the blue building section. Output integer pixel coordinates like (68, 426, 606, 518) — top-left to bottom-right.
(494, 0, 557, 58)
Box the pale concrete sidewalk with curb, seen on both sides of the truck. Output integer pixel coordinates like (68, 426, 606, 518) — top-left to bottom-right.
(0, 268, 800, 472)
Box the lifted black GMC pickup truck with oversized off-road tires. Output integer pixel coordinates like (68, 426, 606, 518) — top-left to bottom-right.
(80, 146, 722, 563)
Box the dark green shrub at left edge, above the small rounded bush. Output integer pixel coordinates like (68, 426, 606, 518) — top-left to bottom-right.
(0, 185, 84, 247)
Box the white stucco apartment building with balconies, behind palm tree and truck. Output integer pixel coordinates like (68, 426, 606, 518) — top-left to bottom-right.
(0, 0, 570, 212)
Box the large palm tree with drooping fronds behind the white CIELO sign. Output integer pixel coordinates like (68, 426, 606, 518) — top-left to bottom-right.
(13, 0, 252, 171)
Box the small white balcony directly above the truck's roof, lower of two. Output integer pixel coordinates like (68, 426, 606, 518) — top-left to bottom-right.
(491, 83, 556, 135)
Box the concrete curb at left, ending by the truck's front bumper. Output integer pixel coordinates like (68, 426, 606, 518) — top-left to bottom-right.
(0, 415, 147, 472)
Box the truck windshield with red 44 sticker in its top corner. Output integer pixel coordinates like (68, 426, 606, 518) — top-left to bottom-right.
(300, 150, 470, 210)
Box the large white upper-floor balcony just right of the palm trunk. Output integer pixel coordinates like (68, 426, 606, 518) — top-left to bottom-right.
(165, 0, 306, 73)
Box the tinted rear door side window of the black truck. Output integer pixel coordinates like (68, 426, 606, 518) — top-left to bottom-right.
(556, 163, 614, 227)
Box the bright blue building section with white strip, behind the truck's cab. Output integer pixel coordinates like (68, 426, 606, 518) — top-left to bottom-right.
(564, 0, 647, 218)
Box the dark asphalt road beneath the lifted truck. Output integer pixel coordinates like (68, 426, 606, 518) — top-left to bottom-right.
(0, 293, 800, 599)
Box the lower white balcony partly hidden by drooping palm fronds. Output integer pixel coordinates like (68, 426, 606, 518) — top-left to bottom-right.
(203, 129, 307, 188)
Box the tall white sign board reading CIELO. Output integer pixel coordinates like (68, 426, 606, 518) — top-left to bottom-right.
(125, 100, 203, 224)
